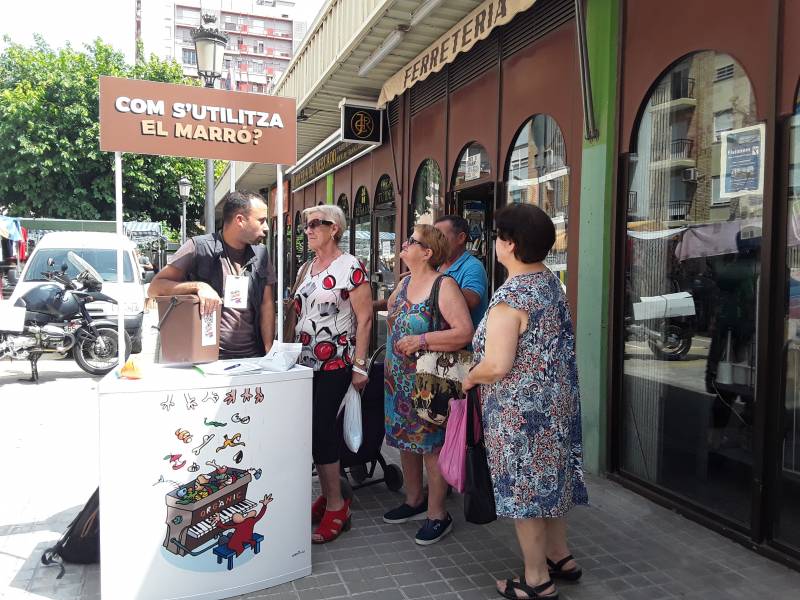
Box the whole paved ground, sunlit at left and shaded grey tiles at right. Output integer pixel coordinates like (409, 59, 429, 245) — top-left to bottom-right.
(0, 312, 800, 600)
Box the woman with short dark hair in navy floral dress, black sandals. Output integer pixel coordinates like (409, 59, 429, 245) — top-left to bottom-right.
(464, 204, 588, 600)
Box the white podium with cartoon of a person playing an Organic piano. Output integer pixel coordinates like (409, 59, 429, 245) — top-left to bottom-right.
(99, 365, 313, 600)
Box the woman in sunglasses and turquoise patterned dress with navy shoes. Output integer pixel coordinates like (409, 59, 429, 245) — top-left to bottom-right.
(383, 225, 473, 546)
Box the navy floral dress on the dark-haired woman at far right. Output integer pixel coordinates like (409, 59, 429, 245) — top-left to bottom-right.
(472, 271, 589, 519)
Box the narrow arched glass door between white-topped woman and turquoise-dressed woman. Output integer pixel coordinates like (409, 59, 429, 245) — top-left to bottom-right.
(370, 175, 397, 348)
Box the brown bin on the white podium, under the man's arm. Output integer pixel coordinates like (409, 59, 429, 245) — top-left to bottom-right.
(156, 295, 221, 365)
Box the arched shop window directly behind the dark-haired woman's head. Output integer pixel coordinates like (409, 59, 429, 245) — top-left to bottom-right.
(506, 115, 569, 285)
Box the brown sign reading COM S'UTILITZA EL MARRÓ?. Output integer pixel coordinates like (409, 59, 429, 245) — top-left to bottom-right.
(100, 77, 297, 165)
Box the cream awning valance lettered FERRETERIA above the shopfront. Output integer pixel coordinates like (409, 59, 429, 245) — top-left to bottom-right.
(378, 0, 536, 106)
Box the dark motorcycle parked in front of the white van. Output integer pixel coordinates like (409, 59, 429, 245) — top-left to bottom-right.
(0, 252, 131, 383)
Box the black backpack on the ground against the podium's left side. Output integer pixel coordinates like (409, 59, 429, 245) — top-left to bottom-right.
(42, 488, 100, 579)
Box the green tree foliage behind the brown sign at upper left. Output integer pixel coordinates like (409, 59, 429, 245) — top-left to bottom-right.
(0, 37, 222, 230)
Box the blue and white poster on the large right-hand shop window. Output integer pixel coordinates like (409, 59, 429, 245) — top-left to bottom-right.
(719, 123, 765, 198)
